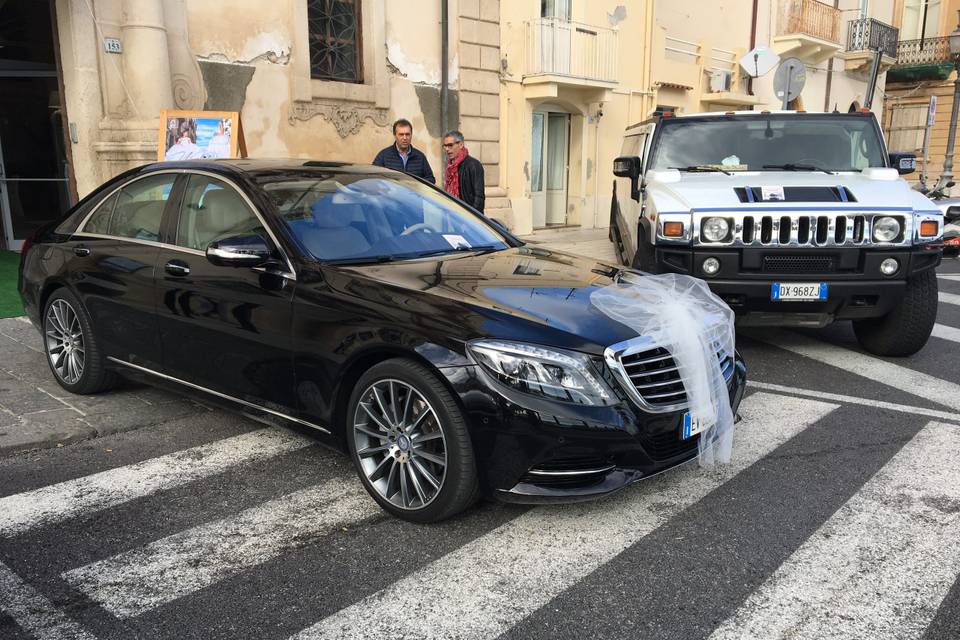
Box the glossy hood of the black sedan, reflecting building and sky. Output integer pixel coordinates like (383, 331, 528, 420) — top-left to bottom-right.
(325, 245, 637, 354)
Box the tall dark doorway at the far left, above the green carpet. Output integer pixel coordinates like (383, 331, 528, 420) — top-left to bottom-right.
(0, 0, 70, 250)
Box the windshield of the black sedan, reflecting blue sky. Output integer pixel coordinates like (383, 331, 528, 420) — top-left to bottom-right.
(255, 173, 508, 262)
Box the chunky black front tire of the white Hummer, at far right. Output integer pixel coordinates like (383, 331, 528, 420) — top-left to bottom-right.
(853, 269, 937, 357)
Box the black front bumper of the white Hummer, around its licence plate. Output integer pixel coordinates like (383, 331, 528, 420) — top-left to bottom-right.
(655, 247, 941, 327)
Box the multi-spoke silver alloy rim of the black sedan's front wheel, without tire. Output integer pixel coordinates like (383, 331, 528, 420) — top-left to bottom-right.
(353, 379, 447, 509)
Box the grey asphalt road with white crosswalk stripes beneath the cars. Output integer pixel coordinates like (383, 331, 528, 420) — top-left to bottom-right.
(0, 261, 960, 640)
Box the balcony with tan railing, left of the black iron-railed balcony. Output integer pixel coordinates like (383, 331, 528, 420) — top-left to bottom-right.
(773, 0, 842, 64)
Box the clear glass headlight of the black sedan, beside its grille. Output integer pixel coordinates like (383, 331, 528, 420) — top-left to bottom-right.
(467, 340, 614, 405)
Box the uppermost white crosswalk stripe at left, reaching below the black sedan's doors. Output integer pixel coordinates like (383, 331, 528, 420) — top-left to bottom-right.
(0, 427, 312, 536)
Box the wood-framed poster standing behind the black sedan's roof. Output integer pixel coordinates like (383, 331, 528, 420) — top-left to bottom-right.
(157, 109, 246, 160)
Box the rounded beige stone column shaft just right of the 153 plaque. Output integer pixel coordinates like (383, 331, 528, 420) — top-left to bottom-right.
(120, 0, 173, 120)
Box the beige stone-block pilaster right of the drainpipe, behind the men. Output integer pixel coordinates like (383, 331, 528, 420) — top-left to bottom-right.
(458, 0, 512, 225)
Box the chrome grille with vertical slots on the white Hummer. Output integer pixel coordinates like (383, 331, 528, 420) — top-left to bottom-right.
(695, 212, 913, 247)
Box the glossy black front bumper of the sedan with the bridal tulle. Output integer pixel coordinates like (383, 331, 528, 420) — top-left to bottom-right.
(445, 354, 746, 504)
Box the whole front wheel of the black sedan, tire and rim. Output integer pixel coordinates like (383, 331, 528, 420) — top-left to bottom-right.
(346, 358, 480, 523)
